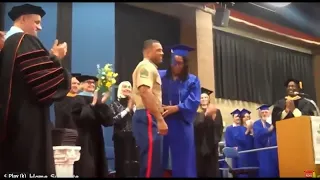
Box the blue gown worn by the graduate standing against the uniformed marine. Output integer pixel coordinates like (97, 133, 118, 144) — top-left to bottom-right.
(159, 70, 201, 177)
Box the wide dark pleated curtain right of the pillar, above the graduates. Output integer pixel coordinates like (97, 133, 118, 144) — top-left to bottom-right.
(214, 30, 316, 104)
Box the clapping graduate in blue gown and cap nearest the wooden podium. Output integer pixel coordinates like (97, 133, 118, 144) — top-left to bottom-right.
(253, 105, 279, 178)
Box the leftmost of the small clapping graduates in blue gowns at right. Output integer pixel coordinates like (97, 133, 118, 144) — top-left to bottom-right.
(224, 109, 243, 168)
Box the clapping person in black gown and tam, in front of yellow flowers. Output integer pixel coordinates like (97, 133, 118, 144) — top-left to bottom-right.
(72, 75, 113, 178)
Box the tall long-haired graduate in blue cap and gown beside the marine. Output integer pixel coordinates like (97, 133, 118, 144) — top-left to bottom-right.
(159, 45, 201, 177)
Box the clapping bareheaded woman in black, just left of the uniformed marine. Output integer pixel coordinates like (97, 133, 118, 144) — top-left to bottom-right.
(110, 81, 139, 178)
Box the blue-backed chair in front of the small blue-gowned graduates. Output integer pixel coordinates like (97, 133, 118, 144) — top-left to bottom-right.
(220, 147, 259, 178)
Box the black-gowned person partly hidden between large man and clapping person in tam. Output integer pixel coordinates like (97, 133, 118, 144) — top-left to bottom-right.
(54, 73, 81, 129)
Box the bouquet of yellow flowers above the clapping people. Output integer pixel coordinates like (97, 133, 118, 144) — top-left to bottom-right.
(97, 64, 118, 92)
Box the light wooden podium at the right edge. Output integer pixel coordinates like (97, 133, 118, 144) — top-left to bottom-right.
(276, 116, 320, 178)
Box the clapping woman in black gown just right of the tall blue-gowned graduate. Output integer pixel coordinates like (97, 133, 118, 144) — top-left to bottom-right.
(194, 88, 223, 178)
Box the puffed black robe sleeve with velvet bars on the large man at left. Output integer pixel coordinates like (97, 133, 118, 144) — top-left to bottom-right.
(16, 34, 66, 102)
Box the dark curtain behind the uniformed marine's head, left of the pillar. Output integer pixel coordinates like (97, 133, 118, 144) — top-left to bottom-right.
(115, 3, 180, 83)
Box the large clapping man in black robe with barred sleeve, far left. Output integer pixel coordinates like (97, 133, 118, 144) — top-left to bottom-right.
(0, 5, 71, 177)
